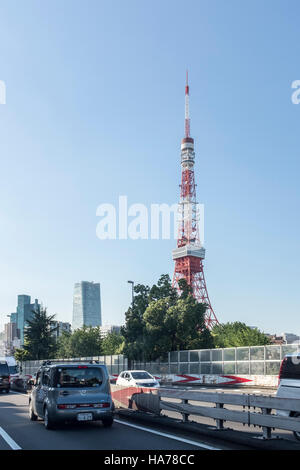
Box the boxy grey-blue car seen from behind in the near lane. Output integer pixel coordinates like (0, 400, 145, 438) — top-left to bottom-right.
(29, 362, 114, 429)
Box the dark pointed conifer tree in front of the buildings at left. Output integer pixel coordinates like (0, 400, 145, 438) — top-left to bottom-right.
(24, 307, 56, 360)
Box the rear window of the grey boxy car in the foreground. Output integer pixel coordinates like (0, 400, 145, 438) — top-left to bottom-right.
(54, 366, 103, 388)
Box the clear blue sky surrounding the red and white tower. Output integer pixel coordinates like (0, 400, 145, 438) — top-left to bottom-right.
(0, 0, 300, 334)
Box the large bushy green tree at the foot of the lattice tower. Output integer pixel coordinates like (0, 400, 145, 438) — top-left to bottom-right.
(122, 275, 213, 360)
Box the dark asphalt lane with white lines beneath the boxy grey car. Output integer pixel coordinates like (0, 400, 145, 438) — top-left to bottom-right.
(0, 392, 243, 452)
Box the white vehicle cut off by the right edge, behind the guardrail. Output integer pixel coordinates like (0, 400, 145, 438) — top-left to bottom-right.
(276, 353, 300, 440)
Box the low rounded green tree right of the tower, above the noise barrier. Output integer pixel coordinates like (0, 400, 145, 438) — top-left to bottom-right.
(211, 322, 270, 348)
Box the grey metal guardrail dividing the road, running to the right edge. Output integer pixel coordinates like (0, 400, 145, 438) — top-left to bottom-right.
(139, 389, 300, 439)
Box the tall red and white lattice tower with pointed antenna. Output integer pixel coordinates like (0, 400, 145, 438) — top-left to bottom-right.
(172, 74, 219, 329)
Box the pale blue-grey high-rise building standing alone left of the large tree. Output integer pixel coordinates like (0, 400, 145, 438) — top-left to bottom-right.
(72, 281, 102, 331)
